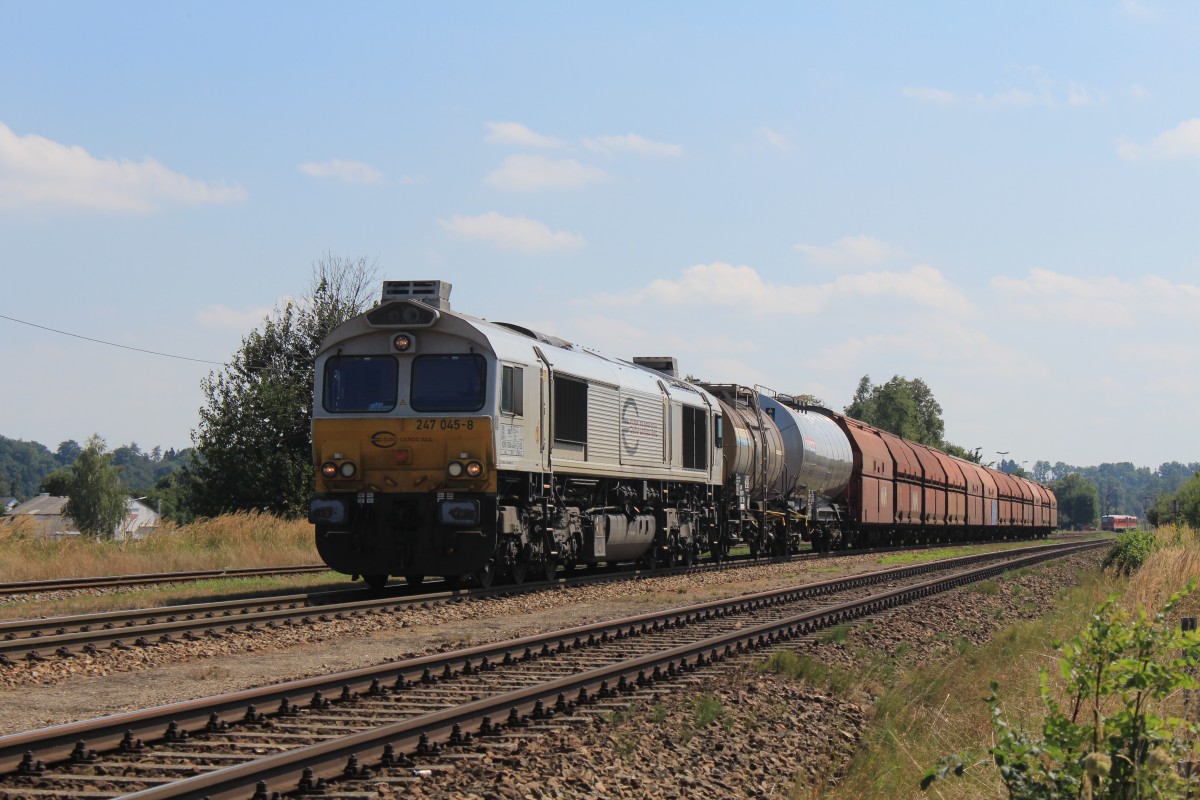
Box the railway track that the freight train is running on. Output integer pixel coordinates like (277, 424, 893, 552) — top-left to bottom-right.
(0, 537, 1075, 666)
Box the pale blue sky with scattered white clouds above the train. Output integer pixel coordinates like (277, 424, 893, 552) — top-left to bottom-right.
(0, 0, 1200, 468)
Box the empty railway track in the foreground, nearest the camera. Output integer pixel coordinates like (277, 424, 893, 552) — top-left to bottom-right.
(0, 542, 1106, 800)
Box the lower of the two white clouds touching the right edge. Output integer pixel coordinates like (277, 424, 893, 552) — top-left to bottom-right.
(991, 267, 1200, 326)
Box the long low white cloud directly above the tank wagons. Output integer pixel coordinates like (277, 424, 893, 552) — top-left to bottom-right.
(595, 261, 972, 317)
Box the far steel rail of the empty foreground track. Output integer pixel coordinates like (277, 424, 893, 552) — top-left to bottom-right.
(0, 543, 1094, 774)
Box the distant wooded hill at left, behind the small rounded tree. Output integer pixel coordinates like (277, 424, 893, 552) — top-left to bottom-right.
(0, 437, 192, 500)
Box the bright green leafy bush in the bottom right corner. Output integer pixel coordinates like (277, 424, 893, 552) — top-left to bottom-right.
(920, 579, 1200, 800)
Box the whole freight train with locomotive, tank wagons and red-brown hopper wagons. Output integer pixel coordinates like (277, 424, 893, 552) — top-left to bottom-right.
(308, 281, 1057, 587)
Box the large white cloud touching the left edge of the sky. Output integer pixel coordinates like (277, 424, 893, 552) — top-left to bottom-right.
(0, 122, 246, 213)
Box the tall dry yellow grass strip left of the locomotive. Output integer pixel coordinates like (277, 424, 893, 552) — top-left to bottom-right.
(0, 512, 319, 582)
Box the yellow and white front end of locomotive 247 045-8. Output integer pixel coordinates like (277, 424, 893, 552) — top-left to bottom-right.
(308, 281, 497, 587)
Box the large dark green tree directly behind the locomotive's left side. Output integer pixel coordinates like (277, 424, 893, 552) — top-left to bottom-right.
(181, 254, 376, 517)
